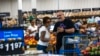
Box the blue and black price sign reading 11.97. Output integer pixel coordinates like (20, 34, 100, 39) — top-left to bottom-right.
(0, 28, 24, 55)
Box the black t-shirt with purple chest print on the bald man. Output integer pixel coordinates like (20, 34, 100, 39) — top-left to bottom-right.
(53, 18, 74, 37)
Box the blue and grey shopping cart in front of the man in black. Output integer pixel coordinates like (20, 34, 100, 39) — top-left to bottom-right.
(59, 34, 88, 56)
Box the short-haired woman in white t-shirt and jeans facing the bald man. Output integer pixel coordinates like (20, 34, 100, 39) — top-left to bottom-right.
(37, 17, 51, 53)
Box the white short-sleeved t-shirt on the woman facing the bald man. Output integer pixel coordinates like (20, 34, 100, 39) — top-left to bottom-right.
(38, 26, 50, 46)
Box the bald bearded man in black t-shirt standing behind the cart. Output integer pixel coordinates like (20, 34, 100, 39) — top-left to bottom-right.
(53, 11, 75, 54)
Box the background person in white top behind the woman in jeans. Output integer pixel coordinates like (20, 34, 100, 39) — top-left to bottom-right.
(27, 19, 38, 37)
